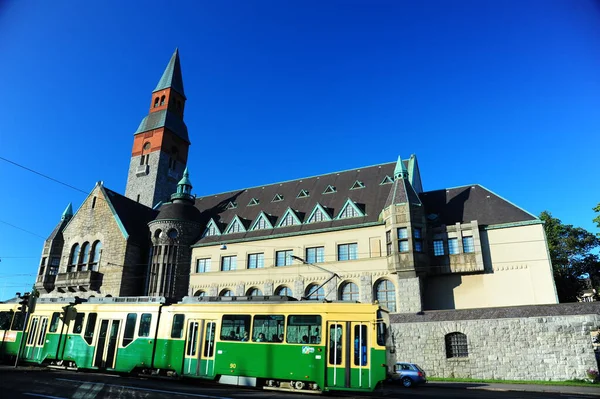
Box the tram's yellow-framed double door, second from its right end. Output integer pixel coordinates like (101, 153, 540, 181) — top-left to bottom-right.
(183, 319, 217, 377)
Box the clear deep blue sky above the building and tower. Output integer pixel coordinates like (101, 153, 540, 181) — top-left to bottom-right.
(0, 0, 600, 298)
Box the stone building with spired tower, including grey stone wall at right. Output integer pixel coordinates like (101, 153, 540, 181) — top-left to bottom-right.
(36, 50, 600, 379)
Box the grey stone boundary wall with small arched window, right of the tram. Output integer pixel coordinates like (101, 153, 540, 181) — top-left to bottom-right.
(391, 302, 600, 381)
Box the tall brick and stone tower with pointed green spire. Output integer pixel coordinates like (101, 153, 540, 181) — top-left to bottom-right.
(125, 49, 191, 207)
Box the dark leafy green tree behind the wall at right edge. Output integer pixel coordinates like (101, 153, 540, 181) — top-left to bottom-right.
(540, 212, 600, 302)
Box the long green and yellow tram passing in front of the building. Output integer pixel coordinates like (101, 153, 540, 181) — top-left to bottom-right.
(7, 296, 389, 392)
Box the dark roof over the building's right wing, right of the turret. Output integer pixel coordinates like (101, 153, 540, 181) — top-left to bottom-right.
(419, 184, 538, 226)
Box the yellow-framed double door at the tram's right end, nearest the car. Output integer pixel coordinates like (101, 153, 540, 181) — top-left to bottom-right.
(327, 321, 371, 388)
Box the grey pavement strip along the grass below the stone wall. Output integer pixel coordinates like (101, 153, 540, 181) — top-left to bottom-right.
(426, 381, 600, 396)
